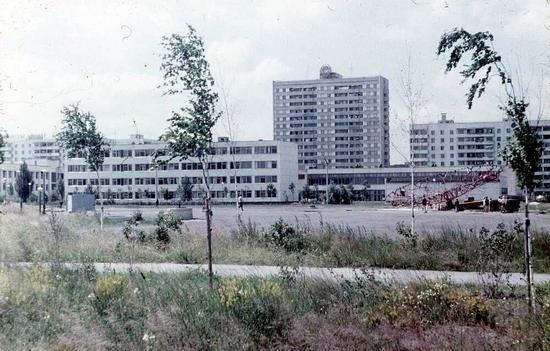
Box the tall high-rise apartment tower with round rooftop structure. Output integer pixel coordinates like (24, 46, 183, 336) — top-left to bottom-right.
(273, 66, 390, 169)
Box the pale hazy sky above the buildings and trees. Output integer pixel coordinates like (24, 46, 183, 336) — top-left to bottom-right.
(0, 0, 550, 163)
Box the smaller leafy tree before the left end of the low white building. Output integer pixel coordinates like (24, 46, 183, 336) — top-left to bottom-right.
(56, 104, 109, 229)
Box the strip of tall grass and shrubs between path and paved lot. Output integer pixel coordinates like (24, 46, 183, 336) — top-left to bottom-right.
(0, 207, 550, 273)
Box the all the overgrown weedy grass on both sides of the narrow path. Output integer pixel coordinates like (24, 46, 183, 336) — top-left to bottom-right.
(0, 207, 550, 351)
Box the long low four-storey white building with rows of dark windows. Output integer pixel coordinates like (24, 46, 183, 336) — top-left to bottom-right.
(64, 135, 298, 202)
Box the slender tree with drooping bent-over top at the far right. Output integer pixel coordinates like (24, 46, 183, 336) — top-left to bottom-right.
(437, 28, 543, 312)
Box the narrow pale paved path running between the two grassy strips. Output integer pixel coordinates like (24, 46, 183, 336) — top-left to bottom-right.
(7, 263, 550, 285)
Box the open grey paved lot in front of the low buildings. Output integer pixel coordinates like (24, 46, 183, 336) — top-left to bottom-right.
(106, 204, 550, 238)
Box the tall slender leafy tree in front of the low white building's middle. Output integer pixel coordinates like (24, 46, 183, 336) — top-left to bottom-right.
(155, 26, 221, 288)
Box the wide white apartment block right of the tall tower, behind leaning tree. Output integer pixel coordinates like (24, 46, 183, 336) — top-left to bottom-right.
(410, 113, 550, 195)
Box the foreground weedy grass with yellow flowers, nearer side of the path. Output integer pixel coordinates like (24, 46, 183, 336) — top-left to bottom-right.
(0, 267, 550, 351)
